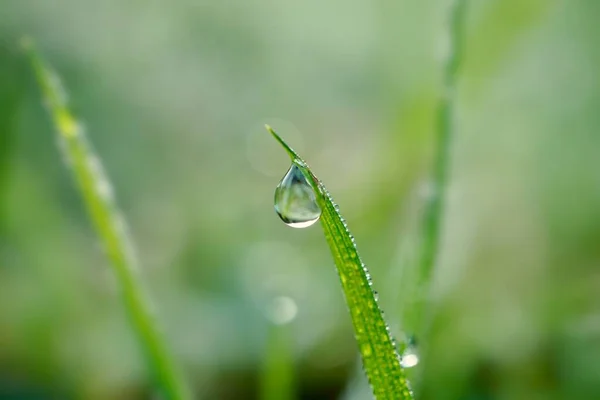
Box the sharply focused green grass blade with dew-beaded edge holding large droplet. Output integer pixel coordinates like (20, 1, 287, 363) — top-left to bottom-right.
(266, 126, 412, 400)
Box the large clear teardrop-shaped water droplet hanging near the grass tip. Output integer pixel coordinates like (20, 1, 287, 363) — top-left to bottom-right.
(275, 164, 321, 228)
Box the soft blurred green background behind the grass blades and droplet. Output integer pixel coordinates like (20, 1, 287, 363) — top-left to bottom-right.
(0, 0, 600, 400)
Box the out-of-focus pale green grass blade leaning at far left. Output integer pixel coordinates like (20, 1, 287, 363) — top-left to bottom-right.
(22, 39, 190, 400)
